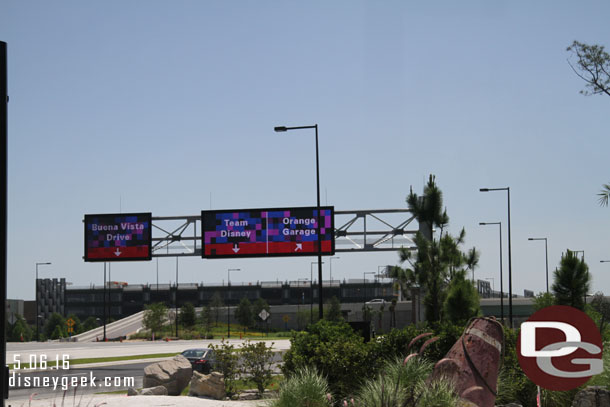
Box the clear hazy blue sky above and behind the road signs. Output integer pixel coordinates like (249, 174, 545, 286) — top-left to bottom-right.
(0, 0, 610, 300)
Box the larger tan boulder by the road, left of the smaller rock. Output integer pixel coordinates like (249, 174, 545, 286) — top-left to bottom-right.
(143, 355, 193, 396)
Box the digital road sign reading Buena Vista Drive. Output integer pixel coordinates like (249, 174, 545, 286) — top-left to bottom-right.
(84, 213, 152, 261)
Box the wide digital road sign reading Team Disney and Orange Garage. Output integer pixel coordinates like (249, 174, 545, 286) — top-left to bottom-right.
(201, 206, 335, 259)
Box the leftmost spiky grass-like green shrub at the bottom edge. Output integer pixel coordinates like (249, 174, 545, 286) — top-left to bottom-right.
(269, 366, 332, 407)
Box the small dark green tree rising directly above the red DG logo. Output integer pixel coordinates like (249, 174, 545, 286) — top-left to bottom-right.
(552, 250, 591, 310)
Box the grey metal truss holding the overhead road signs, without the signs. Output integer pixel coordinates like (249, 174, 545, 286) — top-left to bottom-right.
(152, 209, 418, 257)
